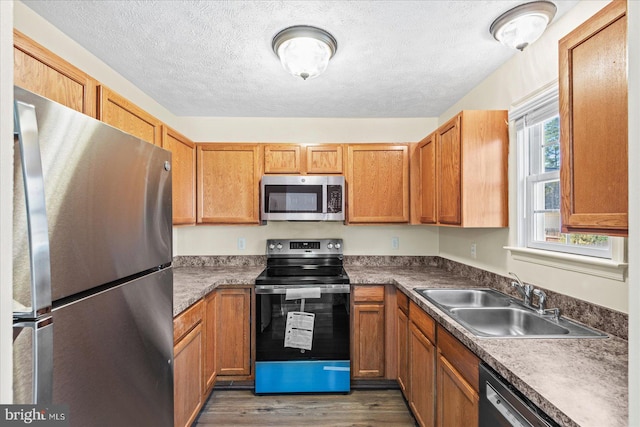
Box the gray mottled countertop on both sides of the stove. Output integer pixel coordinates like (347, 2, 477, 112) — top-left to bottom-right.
(173, 266, 628, 427)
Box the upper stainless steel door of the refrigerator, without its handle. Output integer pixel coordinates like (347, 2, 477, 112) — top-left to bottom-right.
(13, 88, 172, 307)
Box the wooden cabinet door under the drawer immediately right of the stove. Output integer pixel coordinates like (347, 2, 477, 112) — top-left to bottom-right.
(351, 303, 385, 378)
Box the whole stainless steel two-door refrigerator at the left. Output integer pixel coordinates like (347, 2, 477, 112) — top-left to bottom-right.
(13, 87, 173, 426)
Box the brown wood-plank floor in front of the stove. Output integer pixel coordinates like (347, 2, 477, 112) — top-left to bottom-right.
(193, 390, 416, 427)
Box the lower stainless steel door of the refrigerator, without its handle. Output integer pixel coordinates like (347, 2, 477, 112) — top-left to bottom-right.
(52, 268, 173, 427)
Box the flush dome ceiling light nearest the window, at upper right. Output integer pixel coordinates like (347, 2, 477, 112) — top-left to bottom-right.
(489, 1, 556, 50)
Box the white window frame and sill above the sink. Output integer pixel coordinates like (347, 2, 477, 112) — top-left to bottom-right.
(509, 83, 619, 260)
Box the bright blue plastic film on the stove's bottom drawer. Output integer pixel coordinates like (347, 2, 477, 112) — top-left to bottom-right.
(255, 360, 351, 393)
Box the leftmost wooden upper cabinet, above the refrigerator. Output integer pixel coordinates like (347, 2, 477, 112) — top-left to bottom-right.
(13, 30, 96, 117)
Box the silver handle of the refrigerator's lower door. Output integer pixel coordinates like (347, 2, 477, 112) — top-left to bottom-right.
(13, 316, 53, 404)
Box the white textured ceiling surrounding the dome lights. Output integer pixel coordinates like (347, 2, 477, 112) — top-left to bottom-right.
(24, 0, 577, 117)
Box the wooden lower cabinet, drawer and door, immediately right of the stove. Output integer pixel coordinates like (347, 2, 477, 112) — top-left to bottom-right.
(351, 286, 386, 379)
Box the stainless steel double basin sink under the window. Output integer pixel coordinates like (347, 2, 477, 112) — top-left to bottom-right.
(416, 289, 607, 338)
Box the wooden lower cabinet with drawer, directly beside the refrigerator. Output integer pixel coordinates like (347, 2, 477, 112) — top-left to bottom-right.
(173, 302, 204, 427)
